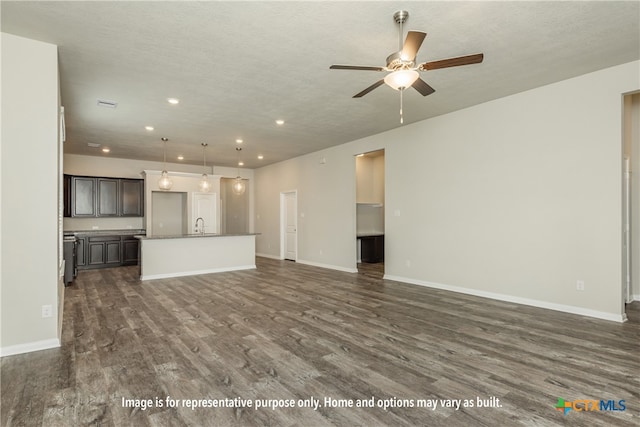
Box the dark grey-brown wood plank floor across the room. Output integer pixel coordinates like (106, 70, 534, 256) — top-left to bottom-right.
(0, 258, 640, 427)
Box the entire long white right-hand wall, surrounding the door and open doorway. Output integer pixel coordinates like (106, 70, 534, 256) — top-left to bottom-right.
(255, 62, 640, 320)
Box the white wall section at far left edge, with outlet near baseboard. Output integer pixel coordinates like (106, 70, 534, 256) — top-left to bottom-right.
(0, 33, 60, 355)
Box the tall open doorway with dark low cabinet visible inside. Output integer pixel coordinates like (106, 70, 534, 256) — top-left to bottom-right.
(355, 150, 385, 277)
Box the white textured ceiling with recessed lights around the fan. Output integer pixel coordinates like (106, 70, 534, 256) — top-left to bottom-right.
(1, 1, 640, 168)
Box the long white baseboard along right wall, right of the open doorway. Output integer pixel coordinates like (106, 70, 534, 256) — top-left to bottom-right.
(384, 274, 627, 323)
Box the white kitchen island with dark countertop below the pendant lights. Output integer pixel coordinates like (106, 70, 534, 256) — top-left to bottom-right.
(136, 233, 256, 280)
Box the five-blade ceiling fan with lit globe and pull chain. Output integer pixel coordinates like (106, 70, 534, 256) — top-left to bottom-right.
(329, 10, 484, 123)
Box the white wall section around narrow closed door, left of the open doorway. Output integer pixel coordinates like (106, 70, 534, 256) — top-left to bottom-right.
(255, 145, 356, 271)
